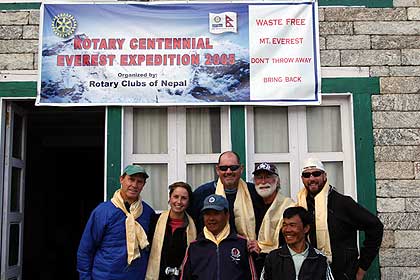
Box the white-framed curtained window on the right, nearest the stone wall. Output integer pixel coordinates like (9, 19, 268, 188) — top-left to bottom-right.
(247, 95, 356, 198)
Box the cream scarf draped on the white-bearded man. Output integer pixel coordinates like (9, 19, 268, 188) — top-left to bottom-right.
(258, 192, 295, 254)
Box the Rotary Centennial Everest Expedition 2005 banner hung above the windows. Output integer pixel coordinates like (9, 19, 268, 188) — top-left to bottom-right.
(36, 1, 321, 106)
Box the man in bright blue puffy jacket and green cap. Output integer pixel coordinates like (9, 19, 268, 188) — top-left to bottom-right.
(77, 165, 154, 280)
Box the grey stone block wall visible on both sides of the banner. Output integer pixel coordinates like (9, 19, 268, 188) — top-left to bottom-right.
(0, 0, 420, 280)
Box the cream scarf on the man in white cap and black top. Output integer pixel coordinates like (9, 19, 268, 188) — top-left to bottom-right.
(298, 182, 332, 262)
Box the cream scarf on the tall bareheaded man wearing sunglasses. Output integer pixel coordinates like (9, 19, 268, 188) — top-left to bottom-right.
(216, 179, 256, 240)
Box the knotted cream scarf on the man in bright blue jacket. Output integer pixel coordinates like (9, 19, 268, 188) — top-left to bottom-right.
(111, 190, 149, 265)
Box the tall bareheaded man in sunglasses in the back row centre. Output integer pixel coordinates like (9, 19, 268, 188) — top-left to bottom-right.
(187, 151, 261, 234)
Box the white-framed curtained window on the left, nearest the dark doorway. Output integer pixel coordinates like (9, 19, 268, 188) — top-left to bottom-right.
(123, 107, 230, 210)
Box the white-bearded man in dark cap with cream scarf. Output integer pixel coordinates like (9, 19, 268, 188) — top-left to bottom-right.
(248, 162, 295, 274)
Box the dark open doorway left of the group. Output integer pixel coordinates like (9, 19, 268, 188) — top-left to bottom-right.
(15, 101, 105, 280)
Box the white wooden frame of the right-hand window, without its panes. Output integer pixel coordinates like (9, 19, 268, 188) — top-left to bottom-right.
(246, 93, 357, 200)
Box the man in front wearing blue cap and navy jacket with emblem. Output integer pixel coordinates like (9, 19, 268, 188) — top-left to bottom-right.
(181, 194, 257, 280)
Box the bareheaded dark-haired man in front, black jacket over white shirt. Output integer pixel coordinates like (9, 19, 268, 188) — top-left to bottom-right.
(261, 207, 334, 280)
